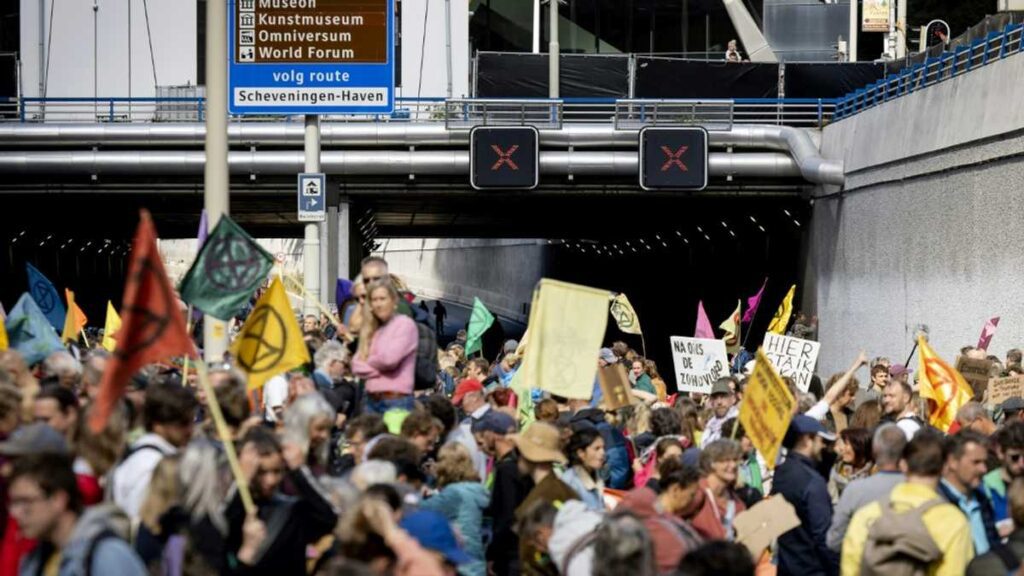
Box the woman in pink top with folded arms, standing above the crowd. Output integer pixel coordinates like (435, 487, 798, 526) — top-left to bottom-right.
(352, 280, 419, 414)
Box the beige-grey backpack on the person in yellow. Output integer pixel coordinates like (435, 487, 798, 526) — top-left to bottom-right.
(860, 496, 948, 576)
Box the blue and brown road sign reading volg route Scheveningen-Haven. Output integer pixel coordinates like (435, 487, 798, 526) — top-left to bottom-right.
(227, 0, 395, 115)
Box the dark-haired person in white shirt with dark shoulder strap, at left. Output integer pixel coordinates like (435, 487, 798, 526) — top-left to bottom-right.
(112, 384, 197, 522)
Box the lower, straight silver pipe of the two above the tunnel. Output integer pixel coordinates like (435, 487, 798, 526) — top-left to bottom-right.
(0, 150, 801, 177)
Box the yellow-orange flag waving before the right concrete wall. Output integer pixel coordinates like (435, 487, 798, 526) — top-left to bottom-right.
(918, 336, 974, 431)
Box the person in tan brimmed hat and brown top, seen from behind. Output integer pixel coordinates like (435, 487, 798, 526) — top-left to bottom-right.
(513, 422, 580, 573)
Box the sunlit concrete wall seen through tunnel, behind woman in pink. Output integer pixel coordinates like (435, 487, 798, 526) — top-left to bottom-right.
(376, 239, 547, 322)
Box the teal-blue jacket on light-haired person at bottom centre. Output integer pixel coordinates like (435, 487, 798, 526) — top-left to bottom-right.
(420, 482, 490, 576)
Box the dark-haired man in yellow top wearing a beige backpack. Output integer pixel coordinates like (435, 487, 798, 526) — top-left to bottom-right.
(842, 430, 974, 576)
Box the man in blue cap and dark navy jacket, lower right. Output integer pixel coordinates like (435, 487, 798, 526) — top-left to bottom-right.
(772, 414, 839, 576)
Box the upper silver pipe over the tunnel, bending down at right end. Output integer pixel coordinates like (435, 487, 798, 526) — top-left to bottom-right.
(0, 123, 844, 184)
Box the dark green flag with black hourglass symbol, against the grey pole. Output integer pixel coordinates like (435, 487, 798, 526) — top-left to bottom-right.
(178, 215, 273, 321)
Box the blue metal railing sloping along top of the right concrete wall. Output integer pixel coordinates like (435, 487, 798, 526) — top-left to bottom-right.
(834, 24, 1024, 120)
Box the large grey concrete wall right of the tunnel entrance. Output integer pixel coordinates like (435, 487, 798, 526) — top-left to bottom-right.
(804, 50, 1024, 376)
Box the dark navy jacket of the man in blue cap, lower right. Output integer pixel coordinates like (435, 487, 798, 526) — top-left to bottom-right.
(772, 452, 839, 576)
